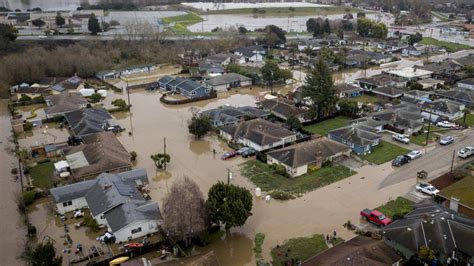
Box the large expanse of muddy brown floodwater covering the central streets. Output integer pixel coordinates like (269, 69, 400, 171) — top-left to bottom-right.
(104, 86, 418, 265)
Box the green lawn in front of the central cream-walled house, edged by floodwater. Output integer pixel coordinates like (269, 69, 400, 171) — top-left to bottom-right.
(241, 160, 356, 195)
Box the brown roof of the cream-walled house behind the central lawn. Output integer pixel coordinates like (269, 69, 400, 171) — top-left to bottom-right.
(268, 137, 350, 168)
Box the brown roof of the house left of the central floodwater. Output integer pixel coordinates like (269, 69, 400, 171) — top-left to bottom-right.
(64, 131, 132, 177)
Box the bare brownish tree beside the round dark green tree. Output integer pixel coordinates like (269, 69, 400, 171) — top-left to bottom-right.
(163, 177, 208, 245)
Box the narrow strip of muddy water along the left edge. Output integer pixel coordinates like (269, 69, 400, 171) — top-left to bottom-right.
(0, 100, 26, 265)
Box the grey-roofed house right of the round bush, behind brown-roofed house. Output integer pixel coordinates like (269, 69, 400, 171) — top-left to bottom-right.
(200, 106, 270, 127)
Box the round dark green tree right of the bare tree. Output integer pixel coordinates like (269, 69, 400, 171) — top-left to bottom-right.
(206, 182, 252, 229)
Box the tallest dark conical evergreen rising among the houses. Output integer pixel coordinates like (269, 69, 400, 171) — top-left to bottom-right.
(303, 57, 338, 119)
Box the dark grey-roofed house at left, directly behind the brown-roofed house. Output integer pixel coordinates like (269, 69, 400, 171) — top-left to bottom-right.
(64, 108, 116, 137)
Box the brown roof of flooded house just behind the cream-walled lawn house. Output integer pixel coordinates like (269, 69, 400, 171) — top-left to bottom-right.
(221, 118, 296, 146)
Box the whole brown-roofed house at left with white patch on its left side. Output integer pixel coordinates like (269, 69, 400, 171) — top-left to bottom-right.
(62, 132, 132, 179)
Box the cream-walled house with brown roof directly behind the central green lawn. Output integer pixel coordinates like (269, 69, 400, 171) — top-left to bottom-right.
(267, 137, 351, 177)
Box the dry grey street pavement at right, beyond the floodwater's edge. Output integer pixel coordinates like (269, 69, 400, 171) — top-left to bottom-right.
(380, 129, 474, 188)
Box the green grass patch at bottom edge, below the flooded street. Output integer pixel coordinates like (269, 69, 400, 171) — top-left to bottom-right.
(272, 235, 328, 265)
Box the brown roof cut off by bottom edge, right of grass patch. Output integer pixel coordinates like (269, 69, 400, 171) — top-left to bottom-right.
(302, 236, 401, 266)
